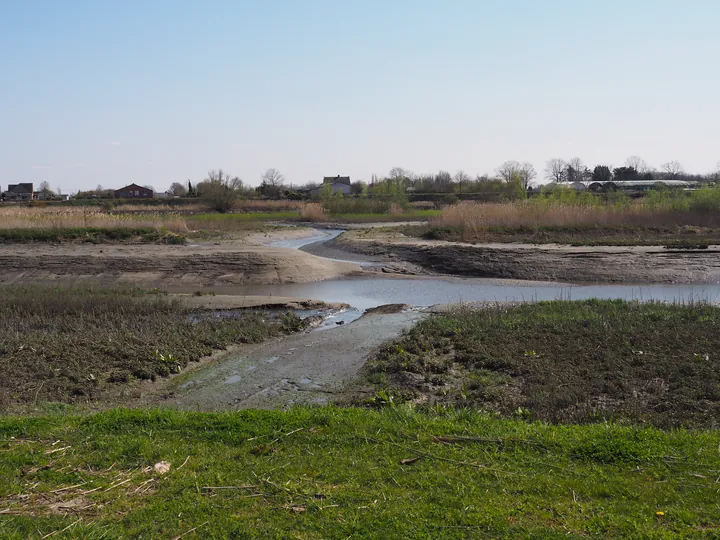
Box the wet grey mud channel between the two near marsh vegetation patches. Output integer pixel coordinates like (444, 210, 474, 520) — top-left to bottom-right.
(152, 312, 426, 411)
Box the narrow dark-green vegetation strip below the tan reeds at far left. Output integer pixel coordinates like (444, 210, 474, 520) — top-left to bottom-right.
(0, 227, 185, 244)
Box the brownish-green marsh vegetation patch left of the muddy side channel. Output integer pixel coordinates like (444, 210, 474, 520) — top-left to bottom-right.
(0, 287, 303, 407)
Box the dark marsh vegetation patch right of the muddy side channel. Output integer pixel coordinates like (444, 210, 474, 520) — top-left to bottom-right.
(368, 300, 720, 427)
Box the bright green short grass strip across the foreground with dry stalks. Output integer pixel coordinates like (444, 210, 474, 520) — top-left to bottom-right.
(0, 406, 720, 539)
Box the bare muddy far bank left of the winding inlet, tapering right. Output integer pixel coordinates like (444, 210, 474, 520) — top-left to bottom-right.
(0, 242, 361, 292)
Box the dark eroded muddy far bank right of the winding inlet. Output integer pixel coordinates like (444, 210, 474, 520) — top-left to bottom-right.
(330, 231, 720, 283)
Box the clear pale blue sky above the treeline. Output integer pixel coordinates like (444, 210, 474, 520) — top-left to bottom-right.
(0, 0, 720, 193)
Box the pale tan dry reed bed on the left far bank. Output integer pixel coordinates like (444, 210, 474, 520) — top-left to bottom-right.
(0, 207, 187, 232)
